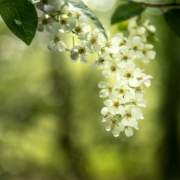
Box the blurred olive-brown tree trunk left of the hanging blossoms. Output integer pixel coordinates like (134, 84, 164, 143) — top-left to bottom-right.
(51, 52, 90, 180)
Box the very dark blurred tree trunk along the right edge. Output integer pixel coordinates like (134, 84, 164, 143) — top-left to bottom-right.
(159, 34, 180, 180)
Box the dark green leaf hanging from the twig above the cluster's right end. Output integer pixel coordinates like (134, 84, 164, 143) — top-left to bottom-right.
(111, 2, 145, 24)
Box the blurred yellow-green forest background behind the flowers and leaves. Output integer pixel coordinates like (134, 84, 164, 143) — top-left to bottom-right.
(0, 0, 180, 180)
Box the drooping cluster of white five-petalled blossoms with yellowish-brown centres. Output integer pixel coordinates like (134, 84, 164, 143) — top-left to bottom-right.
(32, 0, 156, 137)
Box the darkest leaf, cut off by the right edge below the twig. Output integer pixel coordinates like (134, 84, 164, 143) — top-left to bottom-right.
(164, 9, 180, 38)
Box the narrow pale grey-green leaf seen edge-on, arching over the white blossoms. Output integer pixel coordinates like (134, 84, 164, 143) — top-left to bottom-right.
(66, 0, 107, 39)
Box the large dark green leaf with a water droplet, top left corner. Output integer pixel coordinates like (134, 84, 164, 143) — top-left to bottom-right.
(0, 0, 38, 45)
